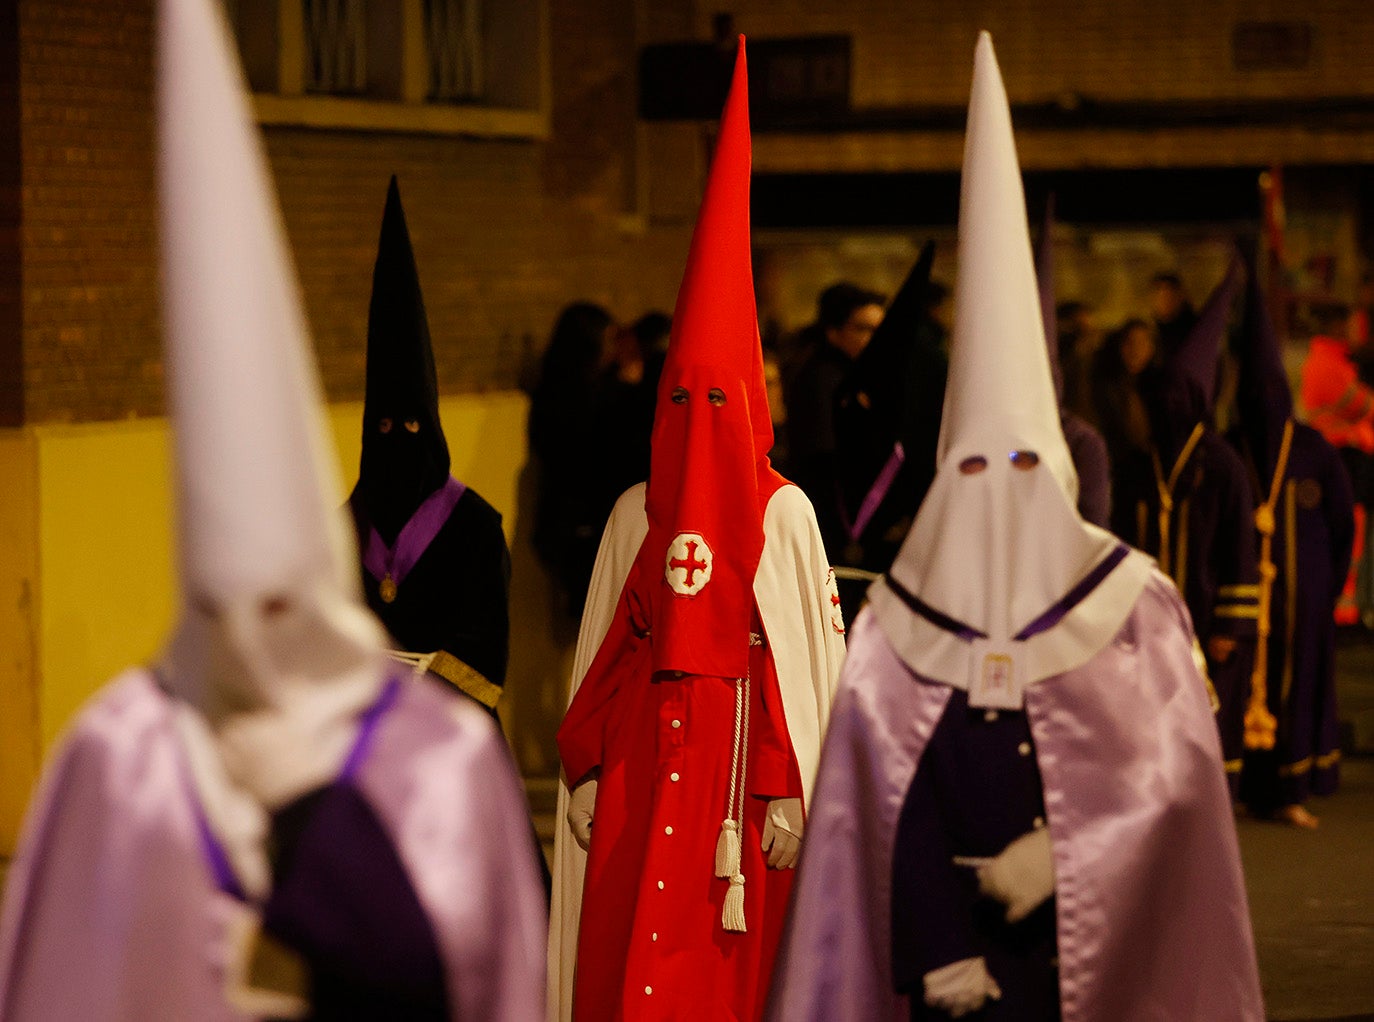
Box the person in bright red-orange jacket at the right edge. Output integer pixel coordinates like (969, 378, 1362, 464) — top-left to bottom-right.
(1301, 302, 1374, 628)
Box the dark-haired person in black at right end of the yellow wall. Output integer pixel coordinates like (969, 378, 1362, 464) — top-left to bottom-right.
(529, 302, 617, 618)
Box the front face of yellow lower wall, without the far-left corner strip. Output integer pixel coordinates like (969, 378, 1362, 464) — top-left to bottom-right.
(26, 393, 528, 747)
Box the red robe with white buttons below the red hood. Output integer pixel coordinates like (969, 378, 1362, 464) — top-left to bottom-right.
(558, 596, 802, 1019)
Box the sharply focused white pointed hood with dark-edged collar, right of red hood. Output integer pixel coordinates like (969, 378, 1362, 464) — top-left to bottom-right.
(870, 33, 1150, 702)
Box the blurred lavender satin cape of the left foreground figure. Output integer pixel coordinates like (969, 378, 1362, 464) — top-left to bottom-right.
(0, 670, 545, 1022)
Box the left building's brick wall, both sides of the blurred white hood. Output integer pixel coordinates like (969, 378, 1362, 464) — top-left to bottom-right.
(24, 0, 698, 422)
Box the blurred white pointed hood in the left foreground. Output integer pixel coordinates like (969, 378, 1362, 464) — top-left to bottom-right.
(157, 0, 385, 868)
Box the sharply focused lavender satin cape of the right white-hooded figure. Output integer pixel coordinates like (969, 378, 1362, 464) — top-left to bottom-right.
(768, 573, 1264, 1022)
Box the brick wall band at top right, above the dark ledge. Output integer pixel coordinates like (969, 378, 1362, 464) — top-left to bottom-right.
(719, 0, 1374, 106)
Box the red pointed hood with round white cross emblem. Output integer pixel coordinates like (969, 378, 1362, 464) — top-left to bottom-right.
(629, 37, 783, 677)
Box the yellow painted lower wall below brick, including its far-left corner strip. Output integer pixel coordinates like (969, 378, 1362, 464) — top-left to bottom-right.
(0, 391, 552, 856)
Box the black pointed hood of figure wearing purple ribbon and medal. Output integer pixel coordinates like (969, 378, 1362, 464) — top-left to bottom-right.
(357, 174, 449, 541)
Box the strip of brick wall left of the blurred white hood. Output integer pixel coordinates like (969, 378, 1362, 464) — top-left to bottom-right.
(19, 0, 159, 422)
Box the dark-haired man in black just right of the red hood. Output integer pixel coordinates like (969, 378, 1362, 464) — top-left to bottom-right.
(783, 282, 886, 562)
